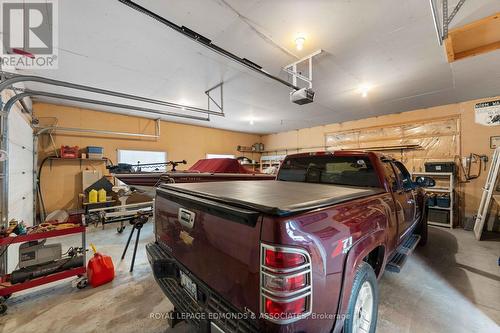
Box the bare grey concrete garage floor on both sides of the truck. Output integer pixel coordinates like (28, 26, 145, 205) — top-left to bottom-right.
(0, 223, 500, 333)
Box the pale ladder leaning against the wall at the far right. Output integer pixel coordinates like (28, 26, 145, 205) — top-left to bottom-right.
(474, 147, 500, 240)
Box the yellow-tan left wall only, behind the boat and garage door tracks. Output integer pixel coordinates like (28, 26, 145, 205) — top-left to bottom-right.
(33, 103, 260, 212)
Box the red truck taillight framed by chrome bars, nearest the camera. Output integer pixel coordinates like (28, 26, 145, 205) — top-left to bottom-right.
(260, 244, 312, 324)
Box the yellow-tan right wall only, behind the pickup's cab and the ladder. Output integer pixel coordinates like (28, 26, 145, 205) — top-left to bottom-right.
(261, 97, 500, 226)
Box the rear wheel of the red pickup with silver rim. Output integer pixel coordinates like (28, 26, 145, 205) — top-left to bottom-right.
(344, 262, 378, 333)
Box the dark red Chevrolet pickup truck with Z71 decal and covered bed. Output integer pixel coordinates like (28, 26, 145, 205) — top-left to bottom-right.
(147, 151, 434, 332)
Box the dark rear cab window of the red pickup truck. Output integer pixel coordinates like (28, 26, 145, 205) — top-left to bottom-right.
(278, 155, 380, 187)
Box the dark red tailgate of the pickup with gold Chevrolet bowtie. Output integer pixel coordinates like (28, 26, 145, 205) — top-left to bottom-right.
(155, 189, 262, 313)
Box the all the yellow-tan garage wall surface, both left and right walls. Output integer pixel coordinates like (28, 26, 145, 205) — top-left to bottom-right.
(33, 97, 500, 226)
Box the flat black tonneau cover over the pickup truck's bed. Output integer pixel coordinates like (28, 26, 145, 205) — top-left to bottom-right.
(158, 181, 384, 216)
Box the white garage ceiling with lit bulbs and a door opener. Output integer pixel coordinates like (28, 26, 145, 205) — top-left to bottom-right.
(15, 0, 500, 133)
